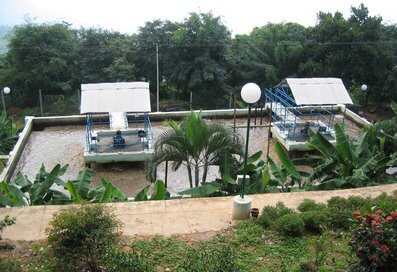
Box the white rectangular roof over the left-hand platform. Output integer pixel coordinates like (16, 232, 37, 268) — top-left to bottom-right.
(80, 82, 150, 113)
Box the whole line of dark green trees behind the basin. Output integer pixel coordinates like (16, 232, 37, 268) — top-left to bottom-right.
(0, 5, 397, 110)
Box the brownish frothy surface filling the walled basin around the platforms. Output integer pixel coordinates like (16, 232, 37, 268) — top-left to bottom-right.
(14, 116, 361, 196)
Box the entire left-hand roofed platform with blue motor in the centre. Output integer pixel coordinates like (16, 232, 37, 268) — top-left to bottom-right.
(80, 82, 153, 164)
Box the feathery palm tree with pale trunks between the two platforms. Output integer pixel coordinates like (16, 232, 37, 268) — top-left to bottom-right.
(147, 112, 243, 188)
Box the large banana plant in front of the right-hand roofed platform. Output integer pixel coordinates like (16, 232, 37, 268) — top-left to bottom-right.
(307, 124, 390, 189)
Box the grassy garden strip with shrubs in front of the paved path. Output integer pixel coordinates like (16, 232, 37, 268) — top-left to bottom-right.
(4, 191, 397, 272)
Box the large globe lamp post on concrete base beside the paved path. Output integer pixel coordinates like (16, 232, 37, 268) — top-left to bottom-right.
(233, 83, 262, 220)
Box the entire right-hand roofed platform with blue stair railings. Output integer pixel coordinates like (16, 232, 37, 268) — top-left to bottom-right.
(265, 78, 353, 150)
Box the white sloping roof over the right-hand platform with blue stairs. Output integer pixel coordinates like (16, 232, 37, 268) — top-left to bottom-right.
(276, 77, 353, 105)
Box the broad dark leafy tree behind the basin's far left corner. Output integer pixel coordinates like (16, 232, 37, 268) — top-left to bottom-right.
(0, 23, 75, 106)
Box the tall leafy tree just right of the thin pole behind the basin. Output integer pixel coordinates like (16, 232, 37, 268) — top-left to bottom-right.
(170, 13, 230, 107)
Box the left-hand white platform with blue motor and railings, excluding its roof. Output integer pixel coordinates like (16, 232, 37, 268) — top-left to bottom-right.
(84, 113, 153, 163)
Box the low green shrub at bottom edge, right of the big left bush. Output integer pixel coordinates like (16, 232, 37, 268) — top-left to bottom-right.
(105, 248, 154, 272)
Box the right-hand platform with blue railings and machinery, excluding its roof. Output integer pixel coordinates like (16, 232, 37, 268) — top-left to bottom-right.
(264, 87, 335, 150)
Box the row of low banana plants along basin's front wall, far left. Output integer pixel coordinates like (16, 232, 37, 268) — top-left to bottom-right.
(0, 164, 127, 207)
